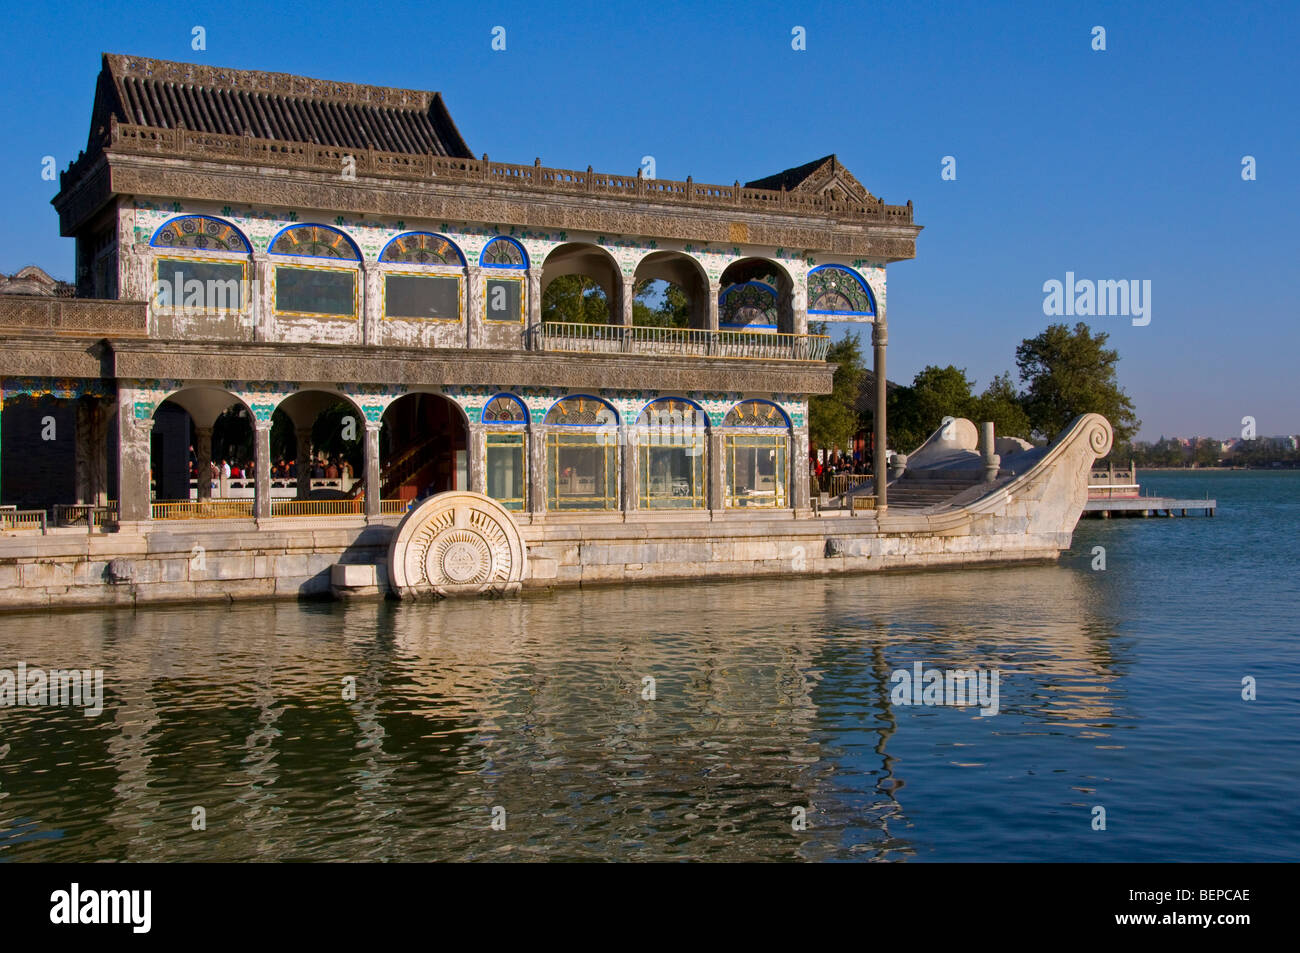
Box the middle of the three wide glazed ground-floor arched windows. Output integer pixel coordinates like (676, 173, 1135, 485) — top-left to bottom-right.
(636, 397, 707, 510)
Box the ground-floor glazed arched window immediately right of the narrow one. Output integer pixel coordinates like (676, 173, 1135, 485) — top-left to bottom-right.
(546, 395, 619, 511)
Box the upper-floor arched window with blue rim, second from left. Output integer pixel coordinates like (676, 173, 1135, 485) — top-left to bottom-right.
(270, 225, 361, 321)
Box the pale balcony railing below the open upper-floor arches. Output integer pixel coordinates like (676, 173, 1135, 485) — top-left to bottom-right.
(533, 321, 831, 361)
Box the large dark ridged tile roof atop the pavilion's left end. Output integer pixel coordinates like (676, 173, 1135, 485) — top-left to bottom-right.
(91, 53, 472, 159)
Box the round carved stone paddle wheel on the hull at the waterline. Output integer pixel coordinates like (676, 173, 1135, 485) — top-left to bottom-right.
(389, 491, 528, 599)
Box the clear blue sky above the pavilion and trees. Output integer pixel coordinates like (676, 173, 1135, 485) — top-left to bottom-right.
(0, 1, 1300, 438)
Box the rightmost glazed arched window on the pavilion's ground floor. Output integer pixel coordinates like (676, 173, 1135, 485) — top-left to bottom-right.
(723, 400, 790, 507)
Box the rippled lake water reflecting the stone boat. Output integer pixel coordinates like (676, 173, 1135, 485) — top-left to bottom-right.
(0, 472, 1300, 861)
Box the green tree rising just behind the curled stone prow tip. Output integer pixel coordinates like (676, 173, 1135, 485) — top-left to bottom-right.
(1015, 321, 1141, 442)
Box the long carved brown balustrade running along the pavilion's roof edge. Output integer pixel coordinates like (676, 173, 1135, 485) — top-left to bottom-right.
(62, 117, 911, 225)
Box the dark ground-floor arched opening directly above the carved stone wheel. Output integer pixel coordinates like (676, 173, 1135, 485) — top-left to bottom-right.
(380, 391, 469, 501)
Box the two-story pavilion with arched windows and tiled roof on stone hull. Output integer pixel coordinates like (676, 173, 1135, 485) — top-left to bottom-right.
(0, 55, 920, 529)
